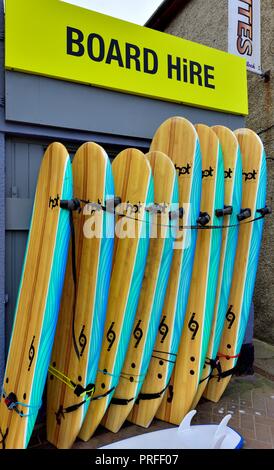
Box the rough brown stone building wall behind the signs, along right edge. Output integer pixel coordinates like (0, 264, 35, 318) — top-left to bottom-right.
(166, 0, 274, 344)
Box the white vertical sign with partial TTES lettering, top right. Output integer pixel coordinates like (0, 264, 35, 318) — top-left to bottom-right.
(228, 0, 262, 74)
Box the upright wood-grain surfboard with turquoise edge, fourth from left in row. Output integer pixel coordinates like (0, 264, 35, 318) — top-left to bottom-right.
(101, 151, 179, 432)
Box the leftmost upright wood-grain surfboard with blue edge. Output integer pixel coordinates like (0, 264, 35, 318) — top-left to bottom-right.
(0, 143, 72, 449)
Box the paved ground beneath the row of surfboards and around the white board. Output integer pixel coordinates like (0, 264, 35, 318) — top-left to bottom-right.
(28, 340, 274, 449)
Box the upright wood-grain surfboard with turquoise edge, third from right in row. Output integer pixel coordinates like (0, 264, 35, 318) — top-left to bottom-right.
(156, 124, 224, 424)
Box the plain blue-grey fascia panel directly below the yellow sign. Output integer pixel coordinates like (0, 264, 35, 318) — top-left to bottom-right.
(5, 72, 243, 140)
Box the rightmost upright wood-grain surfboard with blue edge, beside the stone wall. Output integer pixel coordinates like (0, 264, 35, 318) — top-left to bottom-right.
(204, 129, 267, 402)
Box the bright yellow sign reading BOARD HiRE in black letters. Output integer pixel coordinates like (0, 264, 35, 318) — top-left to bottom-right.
(6, 0, 248, 114)
